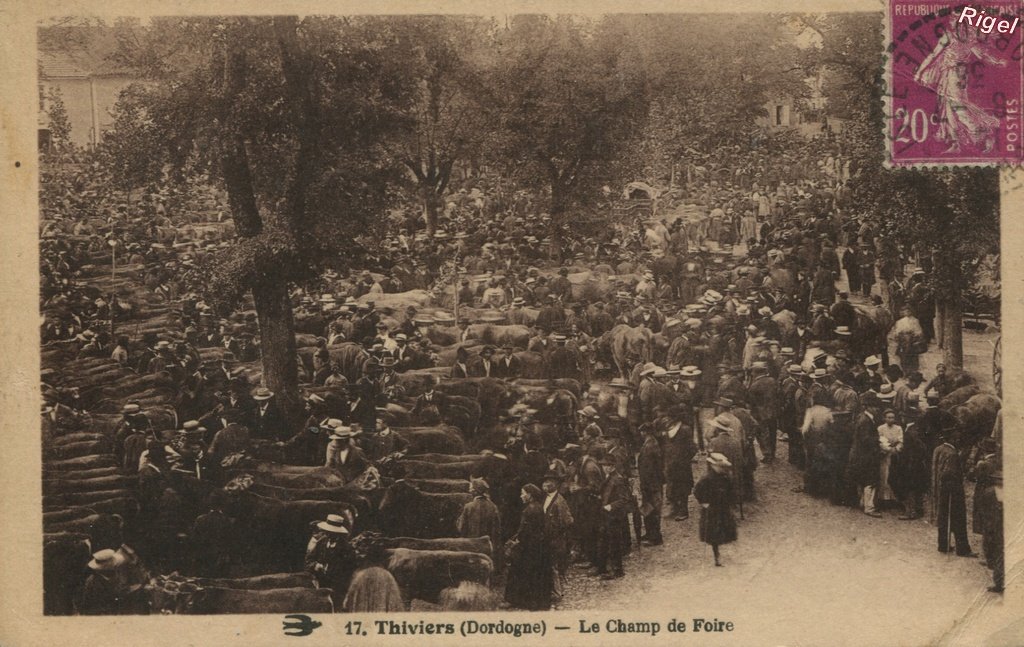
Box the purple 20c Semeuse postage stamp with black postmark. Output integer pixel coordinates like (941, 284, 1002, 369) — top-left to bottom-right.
(885, 0, 1024, 167)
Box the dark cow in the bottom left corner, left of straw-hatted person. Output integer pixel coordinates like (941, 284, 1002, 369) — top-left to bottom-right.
(43, 533, 92, 615)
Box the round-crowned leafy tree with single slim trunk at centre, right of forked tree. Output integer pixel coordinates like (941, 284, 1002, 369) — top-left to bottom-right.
(481, 15, 647, 256)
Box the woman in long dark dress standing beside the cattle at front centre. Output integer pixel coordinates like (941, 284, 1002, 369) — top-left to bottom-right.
(505, 483, 554, 611)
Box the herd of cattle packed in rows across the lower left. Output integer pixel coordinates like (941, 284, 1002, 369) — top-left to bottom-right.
(43, 277, 606, 614)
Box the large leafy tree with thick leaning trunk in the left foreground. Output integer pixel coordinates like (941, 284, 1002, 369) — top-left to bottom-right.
(112, 16, 411, 419)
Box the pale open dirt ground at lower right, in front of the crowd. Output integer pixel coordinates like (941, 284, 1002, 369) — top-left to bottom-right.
(558, 311, 1007, 647)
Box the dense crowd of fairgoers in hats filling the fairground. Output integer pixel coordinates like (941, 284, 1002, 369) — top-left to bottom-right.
(41, 127, 1002, 613)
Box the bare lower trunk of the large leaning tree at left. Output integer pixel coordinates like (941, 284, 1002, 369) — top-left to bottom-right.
(252, 274, 301, 421)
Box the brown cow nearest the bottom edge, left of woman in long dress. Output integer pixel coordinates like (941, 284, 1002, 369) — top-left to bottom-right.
(386, 548, 494, 601)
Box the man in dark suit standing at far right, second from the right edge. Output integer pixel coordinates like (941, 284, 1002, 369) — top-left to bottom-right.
(932, 429, 975, 557)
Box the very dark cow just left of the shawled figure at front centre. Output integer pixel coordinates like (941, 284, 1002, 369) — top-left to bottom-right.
(377, 480, 473, 538)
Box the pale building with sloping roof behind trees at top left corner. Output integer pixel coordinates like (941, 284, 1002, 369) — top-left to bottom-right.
(38, 51, 137, 150)
